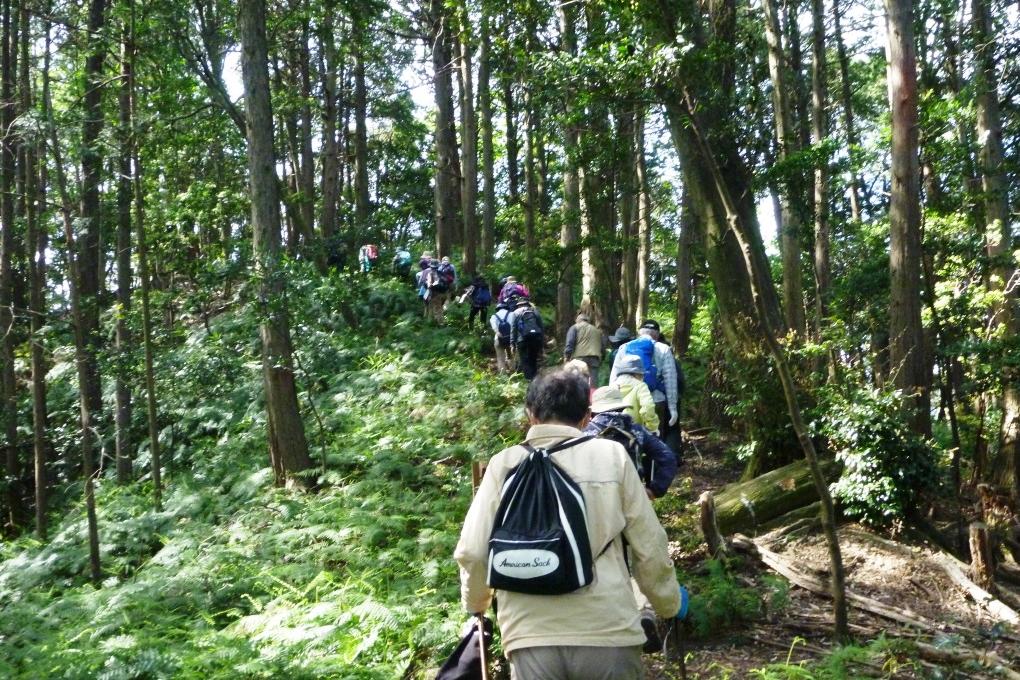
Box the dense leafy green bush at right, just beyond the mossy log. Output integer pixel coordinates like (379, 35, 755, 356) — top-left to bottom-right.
(820, 387, 936, 526)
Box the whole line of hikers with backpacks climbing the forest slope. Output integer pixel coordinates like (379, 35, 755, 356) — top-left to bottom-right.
(367, 247, 684, 680)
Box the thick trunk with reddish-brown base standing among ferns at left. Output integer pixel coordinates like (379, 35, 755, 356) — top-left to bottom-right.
(238, 0, 312, 486)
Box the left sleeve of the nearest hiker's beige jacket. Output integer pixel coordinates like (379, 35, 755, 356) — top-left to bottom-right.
(453, 458, 504, 614)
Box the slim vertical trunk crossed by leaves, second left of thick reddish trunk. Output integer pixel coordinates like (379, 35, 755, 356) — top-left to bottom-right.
(811, 0, 836, 378)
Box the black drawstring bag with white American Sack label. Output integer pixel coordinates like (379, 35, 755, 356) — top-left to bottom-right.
(489, 436, 594, 595)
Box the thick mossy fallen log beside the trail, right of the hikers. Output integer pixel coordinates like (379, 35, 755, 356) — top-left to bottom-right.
(715, 461, 838, 536)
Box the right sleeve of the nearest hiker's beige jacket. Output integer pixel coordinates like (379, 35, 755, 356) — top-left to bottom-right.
(620, 456, 680, 619)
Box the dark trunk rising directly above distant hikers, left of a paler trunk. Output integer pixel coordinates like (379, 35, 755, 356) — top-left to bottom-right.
(429, 0, 460, 257)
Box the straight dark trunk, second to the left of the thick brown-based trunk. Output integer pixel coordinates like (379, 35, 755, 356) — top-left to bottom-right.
(114, 14, 135, 484)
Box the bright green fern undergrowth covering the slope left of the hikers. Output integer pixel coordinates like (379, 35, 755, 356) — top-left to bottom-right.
(0, 276, 523, 680)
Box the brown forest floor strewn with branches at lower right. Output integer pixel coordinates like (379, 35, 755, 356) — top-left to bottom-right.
(646, 439, 1020, 680)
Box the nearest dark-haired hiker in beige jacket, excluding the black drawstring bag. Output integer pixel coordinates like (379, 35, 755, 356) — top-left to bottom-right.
(454, 370, 680, 680)
